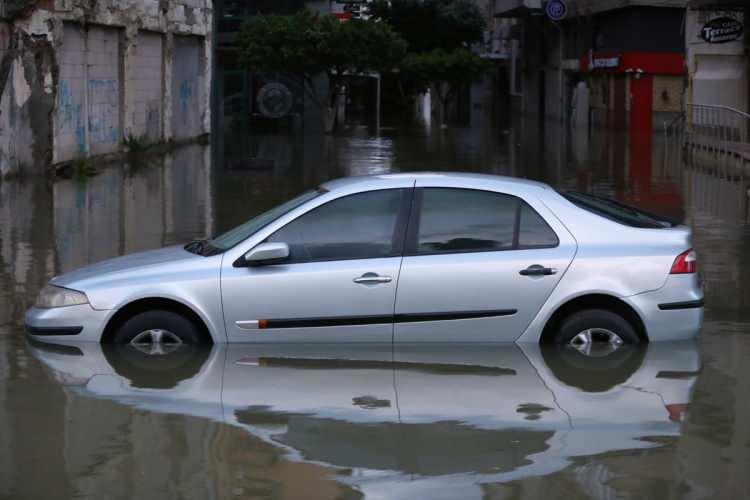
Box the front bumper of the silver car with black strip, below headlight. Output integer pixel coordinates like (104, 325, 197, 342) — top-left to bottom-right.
(25, 304, 111, 342)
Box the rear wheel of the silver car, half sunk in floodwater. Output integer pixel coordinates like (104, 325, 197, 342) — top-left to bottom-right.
(554, 309, 640, 356)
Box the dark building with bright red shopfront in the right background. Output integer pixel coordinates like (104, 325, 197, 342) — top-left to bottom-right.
(495, 0, 685, 132)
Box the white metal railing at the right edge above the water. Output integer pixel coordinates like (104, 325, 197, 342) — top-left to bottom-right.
(683, 103, 750, 151)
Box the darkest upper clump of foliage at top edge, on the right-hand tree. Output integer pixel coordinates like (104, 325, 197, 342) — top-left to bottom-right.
(370, 0, 486, 52)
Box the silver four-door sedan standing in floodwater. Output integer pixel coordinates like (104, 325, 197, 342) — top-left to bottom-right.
(26, 173, 703, 351)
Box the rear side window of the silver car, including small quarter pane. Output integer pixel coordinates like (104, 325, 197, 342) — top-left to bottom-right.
(407, 188, 559, 255)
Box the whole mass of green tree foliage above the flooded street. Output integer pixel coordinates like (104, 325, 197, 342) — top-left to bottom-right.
(237, 4, 486, 127)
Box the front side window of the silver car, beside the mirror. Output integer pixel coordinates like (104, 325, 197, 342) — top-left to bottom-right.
(266, 189, 406, 263)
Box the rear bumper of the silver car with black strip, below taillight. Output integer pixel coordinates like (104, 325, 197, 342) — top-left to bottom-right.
(625, 274, 703, 341)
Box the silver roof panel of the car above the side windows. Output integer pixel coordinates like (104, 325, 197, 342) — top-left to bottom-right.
(321, 172, 552, 192)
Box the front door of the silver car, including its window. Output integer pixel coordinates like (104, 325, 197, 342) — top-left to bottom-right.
(221, 189, 412, 342)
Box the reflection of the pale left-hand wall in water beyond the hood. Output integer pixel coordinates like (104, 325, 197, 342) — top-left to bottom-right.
(54, 146, 213, 272)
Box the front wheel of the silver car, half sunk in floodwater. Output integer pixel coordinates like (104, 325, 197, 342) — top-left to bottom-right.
(112, 310, 202, 346)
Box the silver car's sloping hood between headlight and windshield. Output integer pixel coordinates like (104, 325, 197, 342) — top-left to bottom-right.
(50, 245, 204, 288)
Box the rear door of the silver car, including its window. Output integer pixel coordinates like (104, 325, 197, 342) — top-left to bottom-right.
(394, 183, 576, 342)
